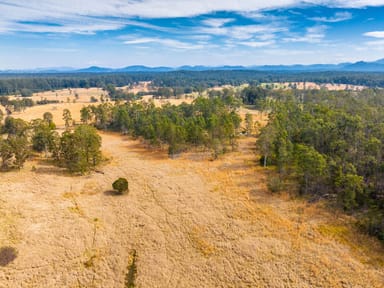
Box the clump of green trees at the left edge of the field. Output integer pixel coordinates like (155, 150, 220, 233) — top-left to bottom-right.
(0, 112, 101, 173)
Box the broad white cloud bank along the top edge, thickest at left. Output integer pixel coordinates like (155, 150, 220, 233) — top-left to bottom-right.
(0, 0, 383, 33)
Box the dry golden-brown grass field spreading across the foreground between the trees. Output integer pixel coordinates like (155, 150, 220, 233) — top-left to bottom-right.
(0, 91, 384, 288)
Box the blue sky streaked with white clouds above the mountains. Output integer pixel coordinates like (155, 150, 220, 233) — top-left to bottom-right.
(0, 0, 384, 70)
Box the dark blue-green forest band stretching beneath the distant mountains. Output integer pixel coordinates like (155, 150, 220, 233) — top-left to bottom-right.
(0, 70, 384, 96)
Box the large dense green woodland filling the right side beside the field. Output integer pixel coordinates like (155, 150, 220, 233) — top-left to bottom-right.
(257, 89, 384, 240)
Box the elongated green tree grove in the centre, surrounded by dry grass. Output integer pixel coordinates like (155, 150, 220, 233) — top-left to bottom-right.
(81, 98, 241, 157)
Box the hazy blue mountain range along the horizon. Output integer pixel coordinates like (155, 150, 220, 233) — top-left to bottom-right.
(0, 59, 384, 74)
